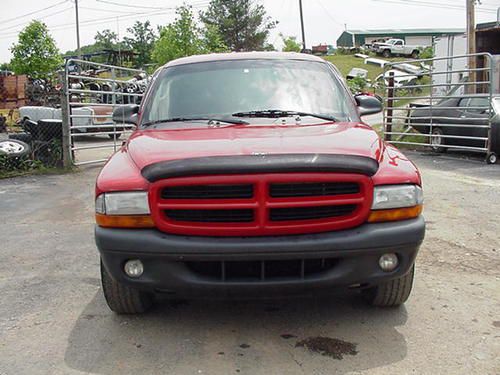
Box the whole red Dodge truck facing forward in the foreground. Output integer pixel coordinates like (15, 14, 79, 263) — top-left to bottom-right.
(95, 52, 425, 313)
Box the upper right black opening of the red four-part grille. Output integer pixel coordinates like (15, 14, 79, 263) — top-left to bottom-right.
(269, 182, 359, 198)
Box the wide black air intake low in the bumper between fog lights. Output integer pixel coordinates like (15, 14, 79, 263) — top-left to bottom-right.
(184, 258, 338, 282)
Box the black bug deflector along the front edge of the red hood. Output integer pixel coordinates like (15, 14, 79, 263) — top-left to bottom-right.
(141, 154, 379, 182)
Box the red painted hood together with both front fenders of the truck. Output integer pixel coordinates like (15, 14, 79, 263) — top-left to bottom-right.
(96, 123, 421, 194)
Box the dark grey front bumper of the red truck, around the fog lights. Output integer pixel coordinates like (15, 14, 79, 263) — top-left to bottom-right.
(95, 217, 425, 297)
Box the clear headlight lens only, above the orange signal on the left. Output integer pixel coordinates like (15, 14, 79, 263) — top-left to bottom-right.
(95, 191, 150, 215)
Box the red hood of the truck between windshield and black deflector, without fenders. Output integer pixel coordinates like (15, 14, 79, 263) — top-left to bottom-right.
(124, 123, 384, 170)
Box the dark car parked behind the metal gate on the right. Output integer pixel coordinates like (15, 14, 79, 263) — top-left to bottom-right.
(408, 94, 500, 163)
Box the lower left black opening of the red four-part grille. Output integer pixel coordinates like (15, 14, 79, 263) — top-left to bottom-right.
(165, 210, 253, 223)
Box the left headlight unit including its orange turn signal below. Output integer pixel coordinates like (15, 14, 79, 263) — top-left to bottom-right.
(95, 191, 154, 228)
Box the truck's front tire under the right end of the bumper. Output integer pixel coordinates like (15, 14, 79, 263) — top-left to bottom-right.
(363, 265, 415, 307)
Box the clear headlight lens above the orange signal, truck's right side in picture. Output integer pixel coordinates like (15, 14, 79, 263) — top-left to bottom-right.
(372, 185, 424, 210)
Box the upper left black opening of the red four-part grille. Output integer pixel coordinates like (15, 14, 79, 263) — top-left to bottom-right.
(161, 184, 253, 199)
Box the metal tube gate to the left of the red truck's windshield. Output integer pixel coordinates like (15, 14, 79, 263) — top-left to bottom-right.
(61, 59, 149, 165)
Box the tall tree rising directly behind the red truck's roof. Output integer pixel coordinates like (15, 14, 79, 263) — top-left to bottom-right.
(200, 0, 277, 51)
